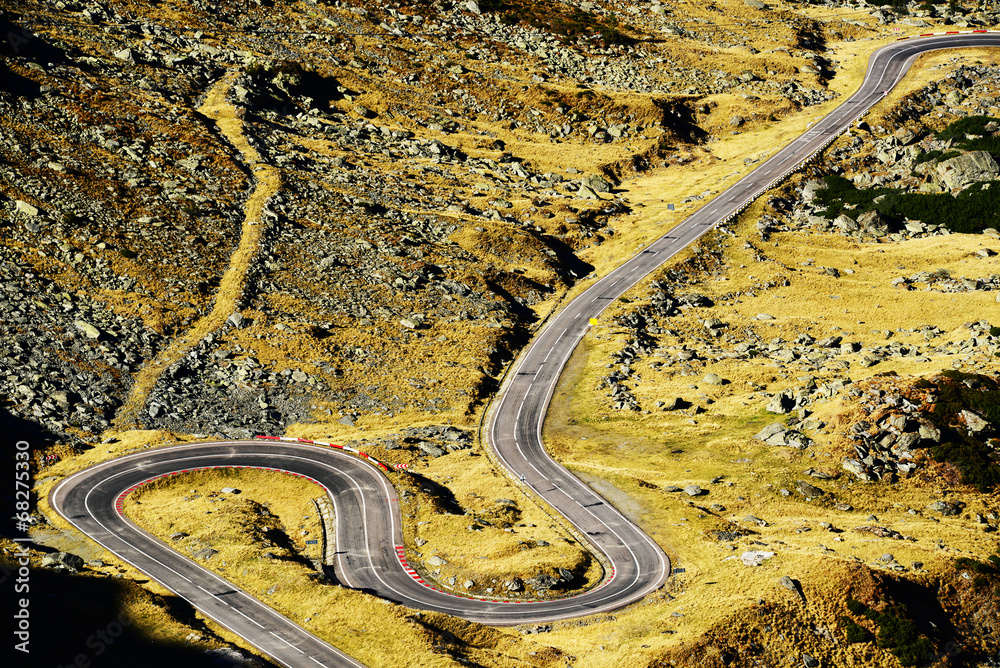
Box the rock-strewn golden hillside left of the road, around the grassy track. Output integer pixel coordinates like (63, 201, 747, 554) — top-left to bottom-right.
(0, 2, 992, 446)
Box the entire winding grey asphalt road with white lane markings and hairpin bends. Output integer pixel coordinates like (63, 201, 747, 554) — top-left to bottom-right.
(50, 33, 1000, 667)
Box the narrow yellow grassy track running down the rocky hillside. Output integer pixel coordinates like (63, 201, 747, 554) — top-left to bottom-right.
(115, 72, 281, 429)
